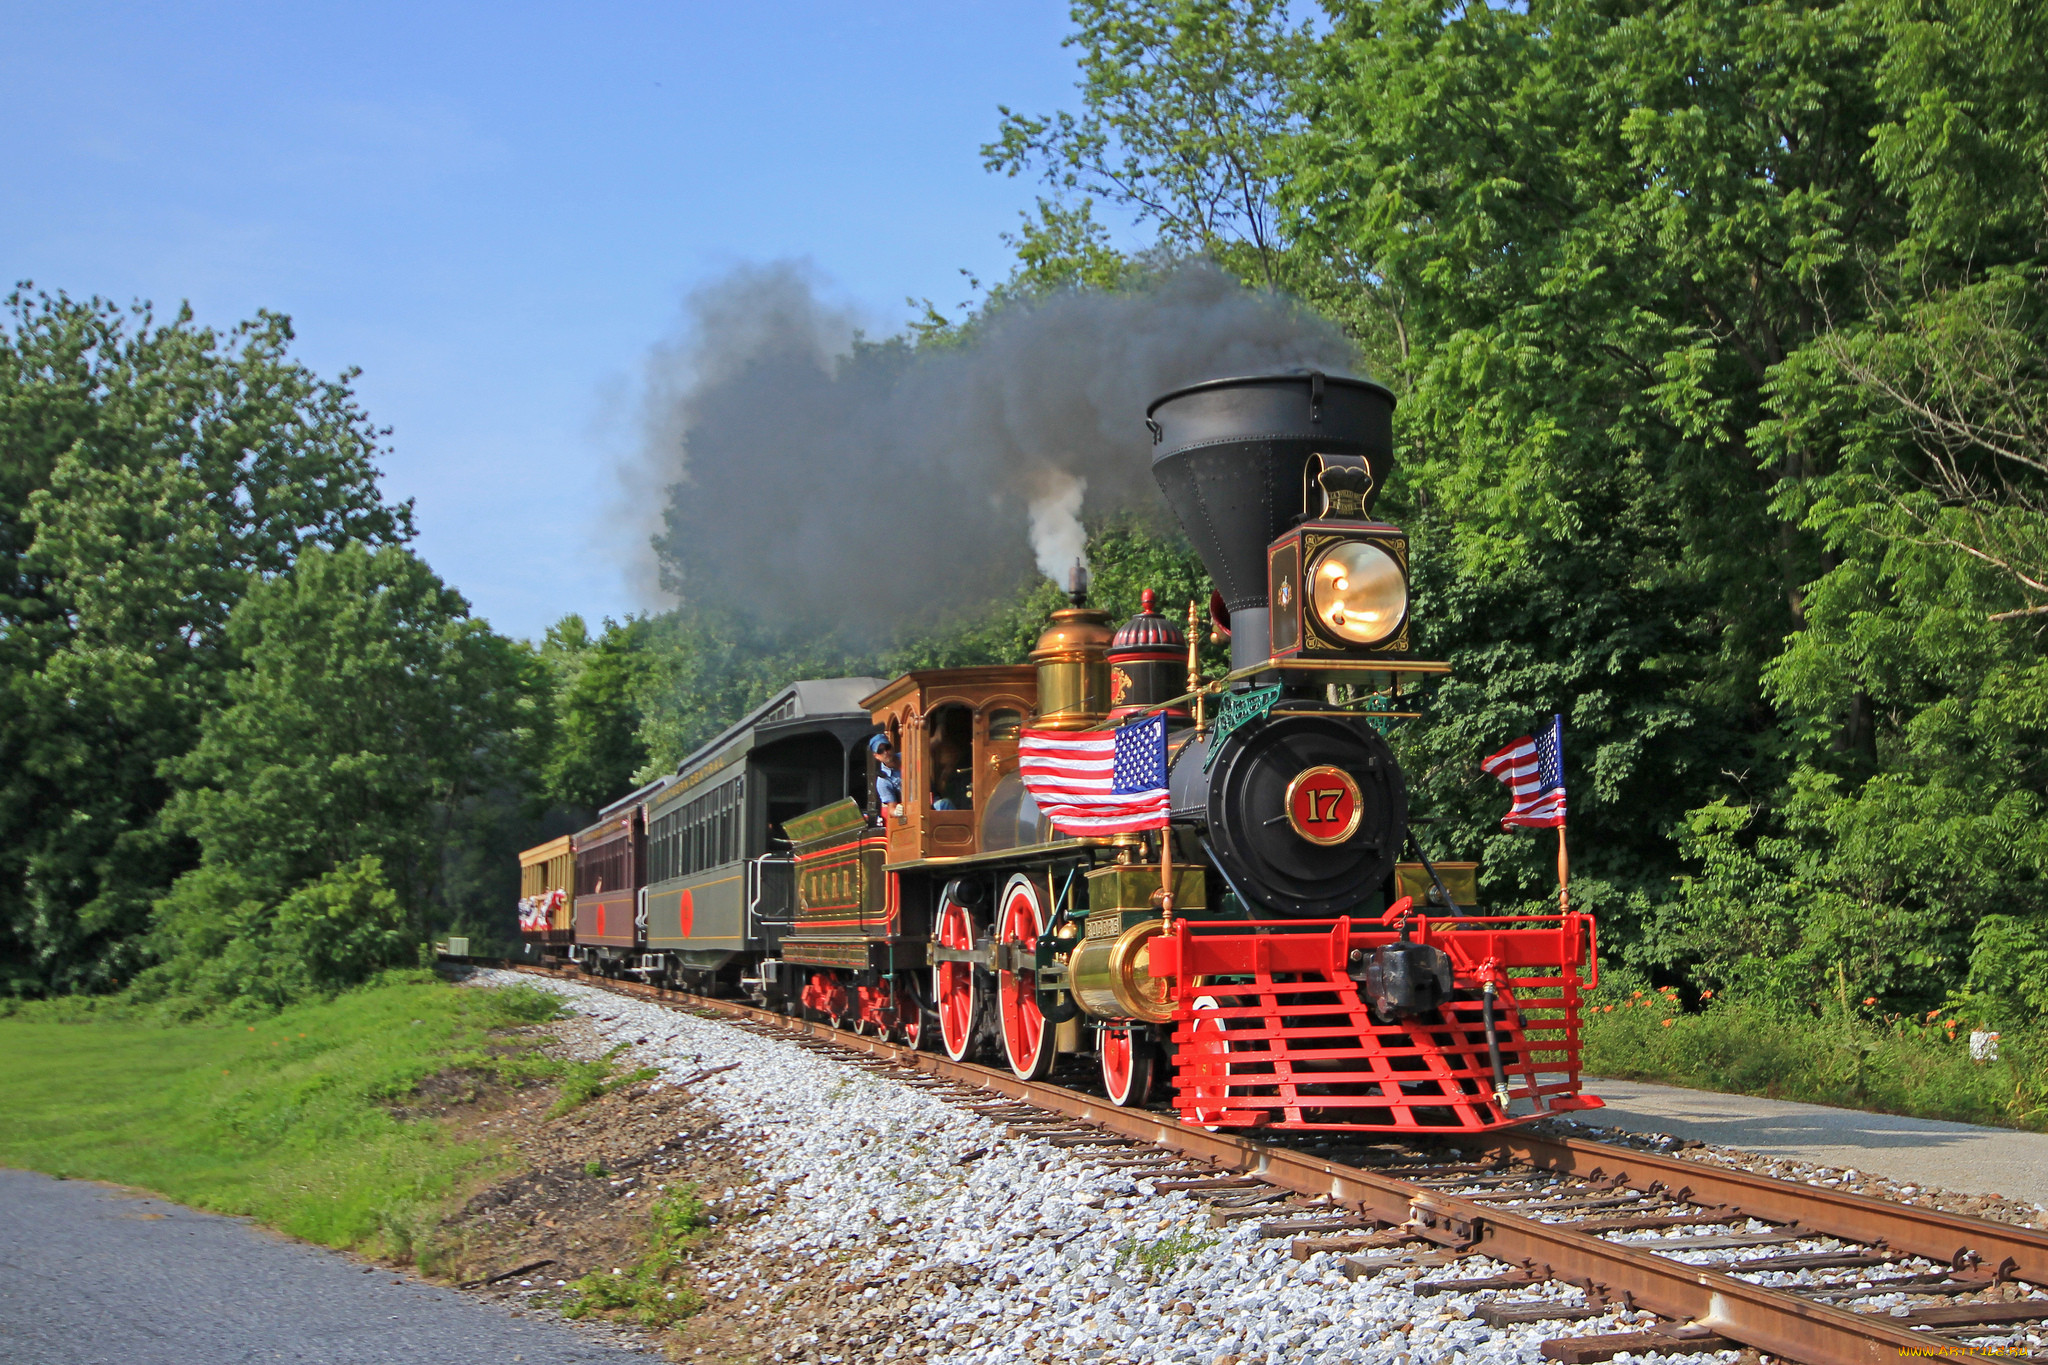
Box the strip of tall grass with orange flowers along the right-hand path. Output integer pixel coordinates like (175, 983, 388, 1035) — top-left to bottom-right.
(1585, 976, 2048, 1132)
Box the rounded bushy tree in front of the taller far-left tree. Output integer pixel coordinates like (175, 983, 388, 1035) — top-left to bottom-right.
(166, 544, 539, 943)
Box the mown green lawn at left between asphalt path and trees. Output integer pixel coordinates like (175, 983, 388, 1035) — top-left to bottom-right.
(0, 972, 563, 1269)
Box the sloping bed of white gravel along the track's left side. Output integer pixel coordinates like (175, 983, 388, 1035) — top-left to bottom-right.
(477, 970, 1735, 1365)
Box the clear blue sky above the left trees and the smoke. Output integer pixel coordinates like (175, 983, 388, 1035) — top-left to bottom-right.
(0, 0, 1130, 636)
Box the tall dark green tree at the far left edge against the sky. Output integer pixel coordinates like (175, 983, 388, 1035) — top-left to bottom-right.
(0, 289, 412, 993)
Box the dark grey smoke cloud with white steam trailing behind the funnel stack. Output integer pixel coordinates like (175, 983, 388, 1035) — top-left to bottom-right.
(629, 262, 1352, 641)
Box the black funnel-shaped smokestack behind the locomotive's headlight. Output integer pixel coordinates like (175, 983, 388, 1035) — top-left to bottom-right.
(1145, 370, 1395, 669)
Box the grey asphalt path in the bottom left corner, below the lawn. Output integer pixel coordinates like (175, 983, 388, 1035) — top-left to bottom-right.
(0, 1171, 637, 1365)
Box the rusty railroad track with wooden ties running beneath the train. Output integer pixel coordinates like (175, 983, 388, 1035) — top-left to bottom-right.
(503, 966, 2048, 1365)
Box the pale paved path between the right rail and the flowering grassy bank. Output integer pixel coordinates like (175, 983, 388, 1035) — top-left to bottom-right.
(1579, 1078, 2048, 1203)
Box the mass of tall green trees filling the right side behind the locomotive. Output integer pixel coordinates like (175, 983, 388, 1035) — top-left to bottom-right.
(1011, 0, 2048, 1013)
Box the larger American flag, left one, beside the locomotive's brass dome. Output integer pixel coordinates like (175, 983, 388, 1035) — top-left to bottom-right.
(1018, 716, 1167, 837)
